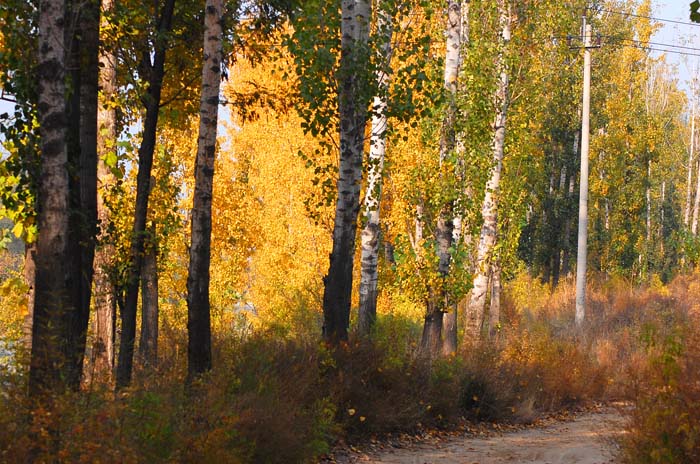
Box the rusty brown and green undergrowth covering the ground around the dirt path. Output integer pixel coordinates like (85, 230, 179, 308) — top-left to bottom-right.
(0, 277, 700, 463)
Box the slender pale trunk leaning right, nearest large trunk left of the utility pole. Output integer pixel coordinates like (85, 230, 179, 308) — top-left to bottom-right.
(465, 0, 510, 340)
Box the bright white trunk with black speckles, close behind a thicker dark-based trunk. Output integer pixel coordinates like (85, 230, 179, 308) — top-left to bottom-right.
(358, 5, 392, 337)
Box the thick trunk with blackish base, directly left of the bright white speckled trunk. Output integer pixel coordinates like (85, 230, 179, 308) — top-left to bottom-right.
(323, 0, 371, 344)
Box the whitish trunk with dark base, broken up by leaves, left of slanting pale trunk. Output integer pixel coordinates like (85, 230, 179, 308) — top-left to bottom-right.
(421, 0, 462, 357)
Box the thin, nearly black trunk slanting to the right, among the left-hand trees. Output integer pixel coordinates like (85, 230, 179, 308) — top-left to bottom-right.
(117, 0, 175, 388)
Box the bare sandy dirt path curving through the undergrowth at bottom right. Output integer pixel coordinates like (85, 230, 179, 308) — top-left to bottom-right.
(344, 410, 623, 464)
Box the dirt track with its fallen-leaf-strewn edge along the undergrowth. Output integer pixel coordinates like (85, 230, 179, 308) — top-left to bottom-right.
(331, 407, 624, 464)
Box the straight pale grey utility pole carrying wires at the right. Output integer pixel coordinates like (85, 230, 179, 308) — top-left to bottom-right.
(576, 12, 593, 327)
